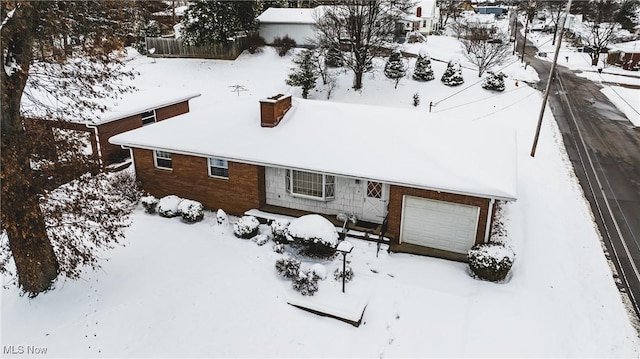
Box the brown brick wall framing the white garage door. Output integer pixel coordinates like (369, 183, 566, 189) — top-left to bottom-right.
(387, 185, 490, 248)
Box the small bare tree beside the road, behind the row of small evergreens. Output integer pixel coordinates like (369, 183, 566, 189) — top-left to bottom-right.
(460, 27, 509, 77)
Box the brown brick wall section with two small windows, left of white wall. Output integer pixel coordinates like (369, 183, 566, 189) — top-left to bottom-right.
(133, 148, 265, 215)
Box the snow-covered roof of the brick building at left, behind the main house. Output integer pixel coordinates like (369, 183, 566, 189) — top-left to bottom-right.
(90, 87, 200, 125)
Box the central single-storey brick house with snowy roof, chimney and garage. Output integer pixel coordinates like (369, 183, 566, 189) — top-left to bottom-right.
(109, 95, 516, 260)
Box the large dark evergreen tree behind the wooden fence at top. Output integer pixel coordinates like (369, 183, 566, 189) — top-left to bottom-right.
(182, 0, 258, 46)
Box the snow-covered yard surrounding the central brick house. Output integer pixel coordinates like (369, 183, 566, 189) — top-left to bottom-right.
(0, 33, 640, 358)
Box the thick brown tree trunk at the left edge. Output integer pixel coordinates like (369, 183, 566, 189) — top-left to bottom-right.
(0, 2, 58, 296)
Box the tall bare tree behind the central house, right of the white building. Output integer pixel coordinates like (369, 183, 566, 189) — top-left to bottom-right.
(316, 0, 411, 89)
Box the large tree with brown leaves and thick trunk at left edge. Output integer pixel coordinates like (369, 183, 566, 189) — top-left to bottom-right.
(0, 0, 134, 296)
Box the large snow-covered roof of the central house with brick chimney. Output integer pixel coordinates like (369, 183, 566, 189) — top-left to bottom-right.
(109, 98, 516, 200)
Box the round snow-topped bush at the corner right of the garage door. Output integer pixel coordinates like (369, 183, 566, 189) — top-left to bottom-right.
(467, 243, 516, 282)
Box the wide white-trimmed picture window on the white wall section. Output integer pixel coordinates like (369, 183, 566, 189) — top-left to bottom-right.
(285, 170, 336, 200)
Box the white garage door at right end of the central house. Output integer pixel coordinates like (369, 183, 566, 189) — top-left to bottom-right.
(400, 196, 480, 253)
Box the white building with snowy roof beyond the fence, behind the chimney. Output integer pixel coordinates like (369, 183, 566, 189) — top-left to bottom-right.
(258, 6, 324, 46)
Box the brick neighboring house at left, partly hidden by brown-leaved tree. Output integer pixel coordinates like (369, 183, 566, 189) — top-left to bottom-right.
(25, 87, 200, 167)
